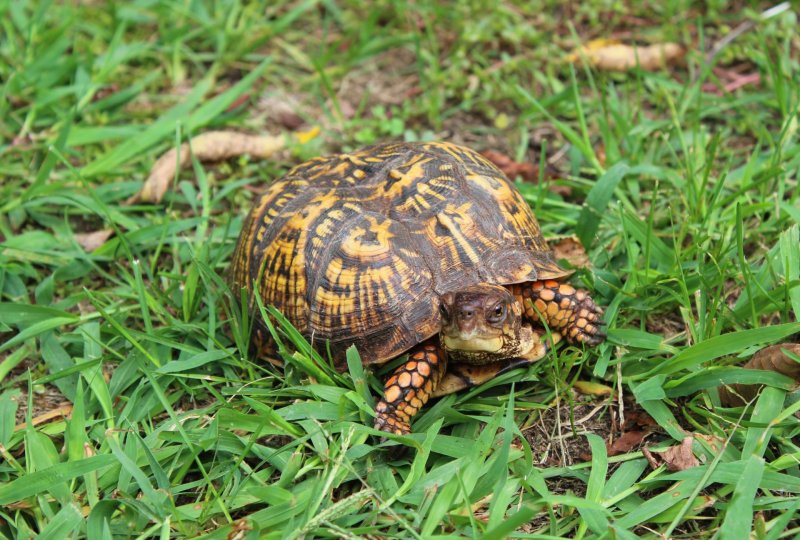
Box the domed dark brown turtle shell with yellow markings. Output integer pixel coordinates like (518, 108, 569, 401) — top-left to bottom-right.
(232, 142, 569, 366)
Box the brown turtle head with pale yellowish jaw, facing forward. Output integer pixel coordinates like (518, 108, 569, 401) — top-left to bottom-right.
(439, 283, 534, 364)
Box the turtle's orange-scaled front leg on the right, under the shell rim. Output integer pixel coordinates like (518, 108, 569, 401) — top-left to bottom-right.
(514, 279, 606, 345)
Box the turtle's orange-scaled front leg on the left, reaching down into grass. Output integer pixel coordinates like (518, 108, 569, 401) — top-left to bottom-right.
(375, 342, 447, 435)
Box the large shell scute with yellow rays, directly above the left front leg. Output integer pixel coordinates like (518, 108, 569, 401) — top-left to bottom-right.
(308, 212, 438, 361)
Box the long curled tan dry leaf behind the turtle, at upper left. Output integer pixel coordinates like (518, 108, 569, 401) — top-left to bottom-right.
(134, 131, 286, 203)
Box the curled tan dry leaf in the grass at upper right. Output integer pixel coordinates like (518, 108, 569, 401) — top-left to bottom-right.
(567, 39, 686, 71)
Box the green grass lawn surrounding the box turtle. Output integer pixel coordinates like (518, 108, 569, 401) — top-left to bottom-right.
(0, 0, 800, 539)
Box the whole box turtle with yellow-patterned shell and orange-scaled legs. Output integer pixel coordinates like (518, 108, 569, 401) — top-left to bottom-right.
(232, 142, 605, 434)
